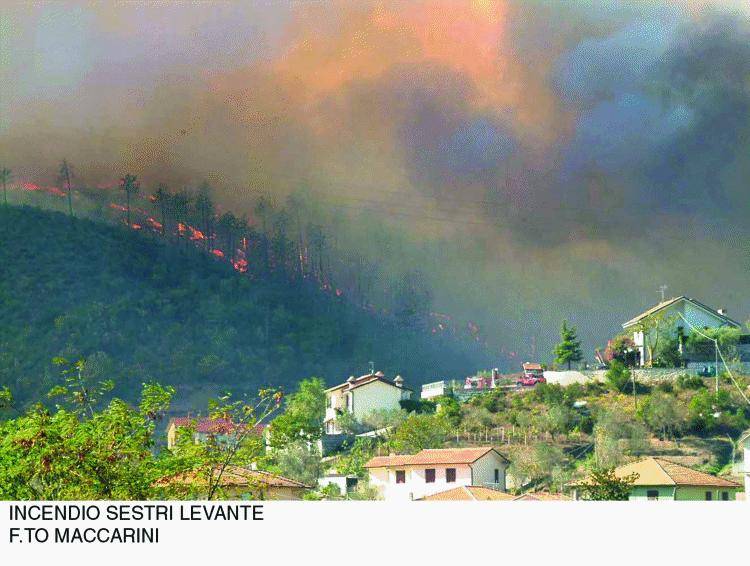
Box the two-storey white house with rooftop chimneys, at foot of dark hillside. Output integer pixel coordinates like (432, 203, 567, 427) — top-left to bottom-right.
(324, 371, 412, 434)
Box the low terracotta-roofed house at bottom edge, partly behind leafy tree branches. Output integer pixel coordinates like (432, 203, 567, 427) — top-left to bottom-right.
(154, 466, 311, 501)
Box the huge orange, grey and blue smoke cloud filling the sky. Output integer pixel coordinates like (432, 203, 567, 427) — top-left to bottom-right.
(0, 0, 750, 364)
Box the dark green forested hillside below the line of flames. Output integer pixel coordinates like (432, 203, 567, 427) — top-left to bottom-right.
(0, 207, 487, 408)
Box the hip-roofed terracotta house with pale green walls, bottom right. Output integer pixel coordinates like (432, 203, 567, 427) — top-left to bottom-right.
(571, 457, 742, 501)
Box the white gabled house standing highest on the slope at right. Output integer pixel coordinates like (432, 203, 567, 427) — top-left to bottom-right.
(622, 296, 742, 366)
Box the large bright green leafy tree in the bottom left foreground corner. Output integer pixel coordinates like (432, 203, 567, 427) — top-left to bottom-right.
(0, 360, 174, 500)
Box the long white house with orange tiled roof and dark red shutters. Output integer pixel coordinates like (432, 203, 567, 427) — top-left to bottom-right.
(365, 446, 509, 501)
